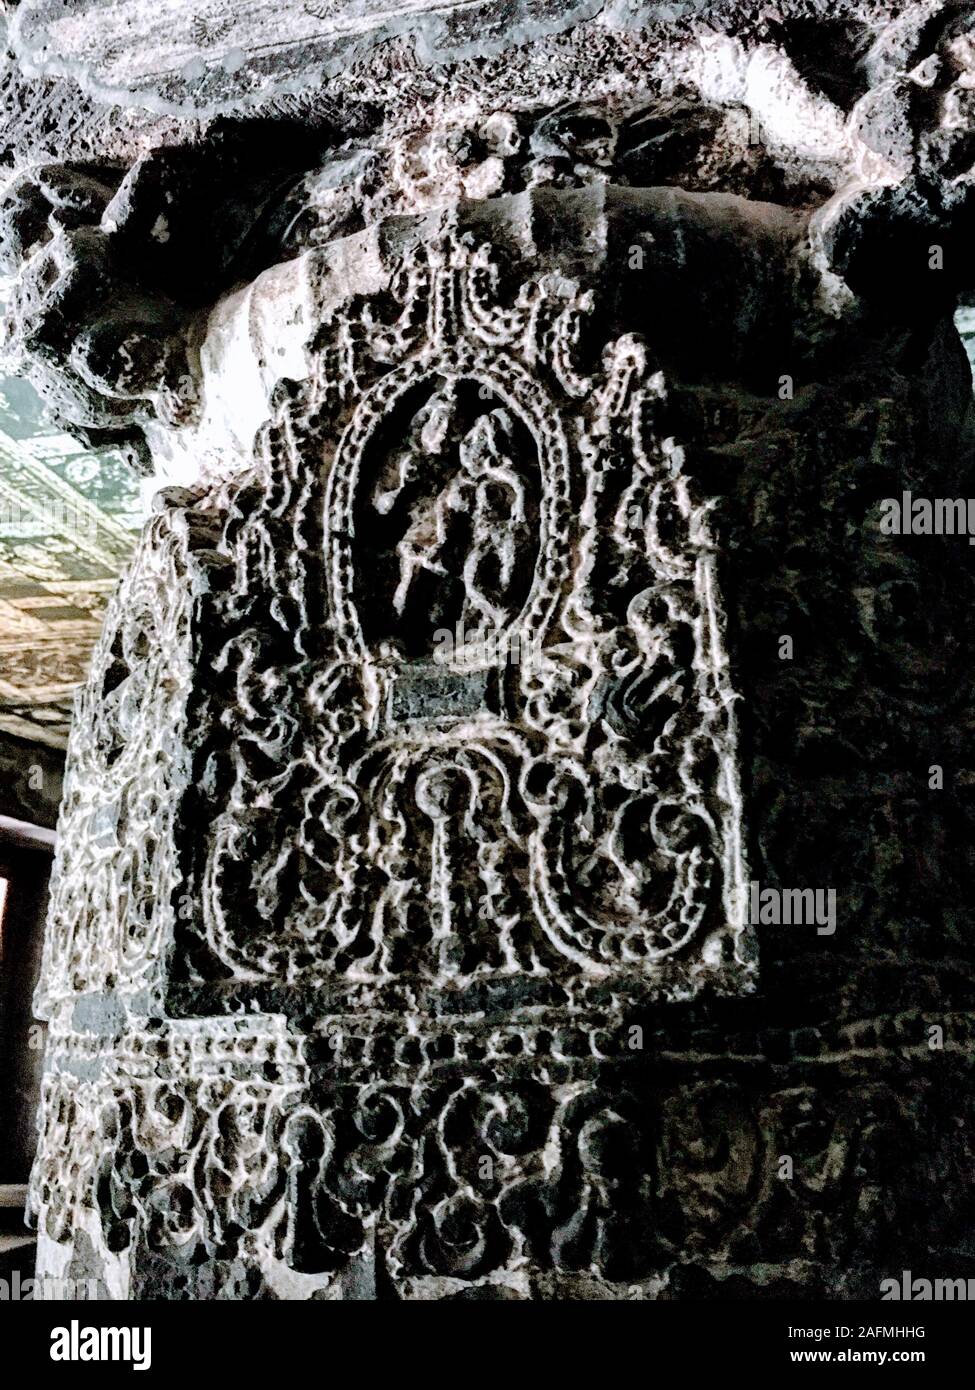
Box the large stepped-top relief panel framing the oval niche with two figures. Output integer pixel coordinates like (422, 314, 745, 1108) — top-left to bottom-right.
(168, 222, 747, 992)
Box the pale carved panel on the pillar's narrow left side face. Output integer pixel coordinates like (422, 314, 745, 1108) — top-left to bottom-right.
(40, 510, 223, 1001)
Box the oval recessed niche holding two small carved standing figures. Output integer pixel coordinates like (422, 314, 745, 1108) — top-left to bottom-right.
(353, 377, 540, 659)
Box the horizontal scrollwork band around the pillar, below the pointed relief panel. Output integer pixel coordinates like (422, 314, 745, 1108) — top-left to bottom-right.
(33, 1015, 971, 1298)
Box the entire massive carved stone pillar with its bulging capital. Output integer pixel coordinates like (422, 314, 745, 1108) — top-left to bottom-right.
(7, 7, 972, 1298)
